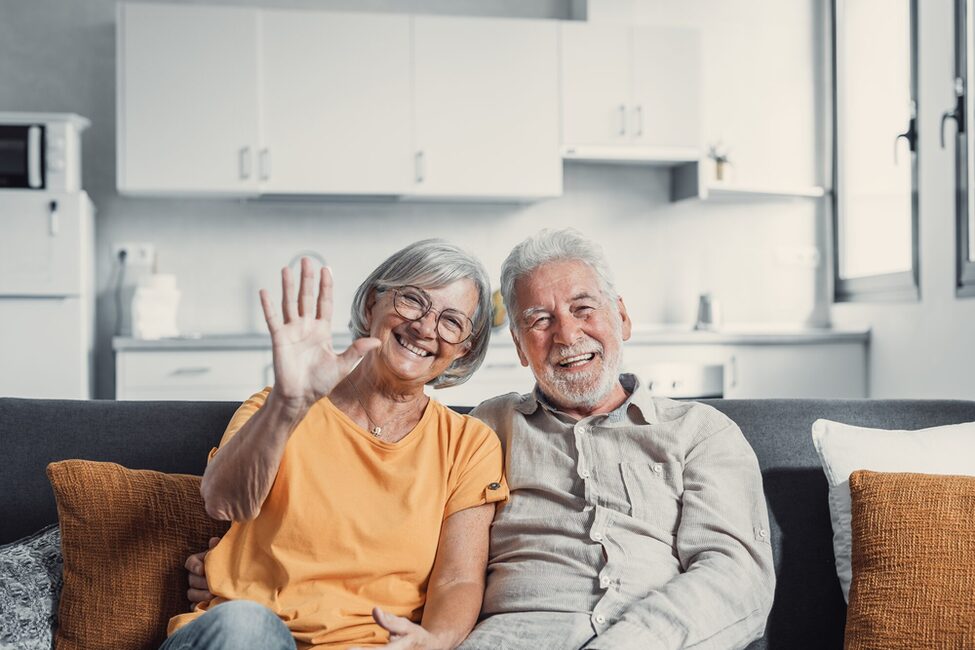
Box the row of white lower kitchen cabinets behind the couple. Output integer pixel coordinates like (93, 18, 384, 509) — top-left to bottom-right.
(114, 329, 869, 406)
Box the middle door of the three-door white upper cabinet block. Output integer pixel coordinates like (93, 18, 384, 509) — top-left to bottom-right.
(257, 10, 413, 194)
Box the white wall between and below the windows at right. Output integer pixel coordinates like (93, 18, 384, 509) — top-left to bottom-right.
(832, 0, 975, 399)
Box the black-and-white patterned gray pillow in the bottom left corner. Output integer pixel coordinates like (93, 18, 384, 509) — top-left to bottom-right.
(0, 524, 62, 650)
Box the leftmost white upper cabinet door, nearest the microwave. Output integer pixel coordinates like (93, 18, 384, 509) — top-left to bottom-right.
(117, 4, 259, 195)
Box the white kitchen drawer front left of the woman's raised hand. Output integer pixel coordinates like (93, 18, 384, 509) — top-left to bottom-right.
(115, 350, 273, 400)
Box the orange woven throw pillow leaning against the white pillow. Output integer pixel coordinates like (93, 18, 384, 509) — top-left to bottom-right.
(846, 470, 975, 650)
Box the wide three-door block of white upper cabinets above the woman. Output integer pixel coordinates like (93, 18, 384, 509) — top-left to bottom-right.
(118, 4, 562, 200)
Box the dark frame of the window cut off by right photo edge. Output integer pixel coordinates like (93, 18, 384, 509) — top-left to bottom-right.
(956, 0, 975, 298)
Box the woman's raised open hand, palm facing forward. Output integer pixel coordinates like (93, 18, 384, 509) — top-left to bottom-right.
(260, 258, 380, 412)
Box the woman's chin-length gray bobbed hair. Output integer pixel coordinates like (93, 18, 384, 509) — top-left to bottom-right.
(349, 239, 491, 388)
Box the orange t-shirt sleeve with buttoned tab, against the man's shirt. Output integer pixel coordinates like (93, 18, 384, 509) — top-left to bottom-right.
(444, 416, 508, 519)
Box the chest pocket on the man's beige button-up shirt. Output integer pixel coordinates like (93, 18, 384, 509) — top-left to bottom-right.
(620, 462, 684, 535)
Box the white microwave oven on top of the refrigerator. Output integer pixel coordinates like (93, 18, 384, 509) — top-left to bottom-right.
(0, 112, 91, 192)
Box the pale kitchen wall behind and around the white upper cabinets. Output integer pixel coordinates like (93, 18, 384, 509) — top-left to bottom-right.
(0, 0, 828, 397)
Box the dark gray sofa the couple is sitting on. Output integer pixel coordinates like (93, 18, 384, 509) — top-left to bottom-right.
(0, 398, 975, 650)
